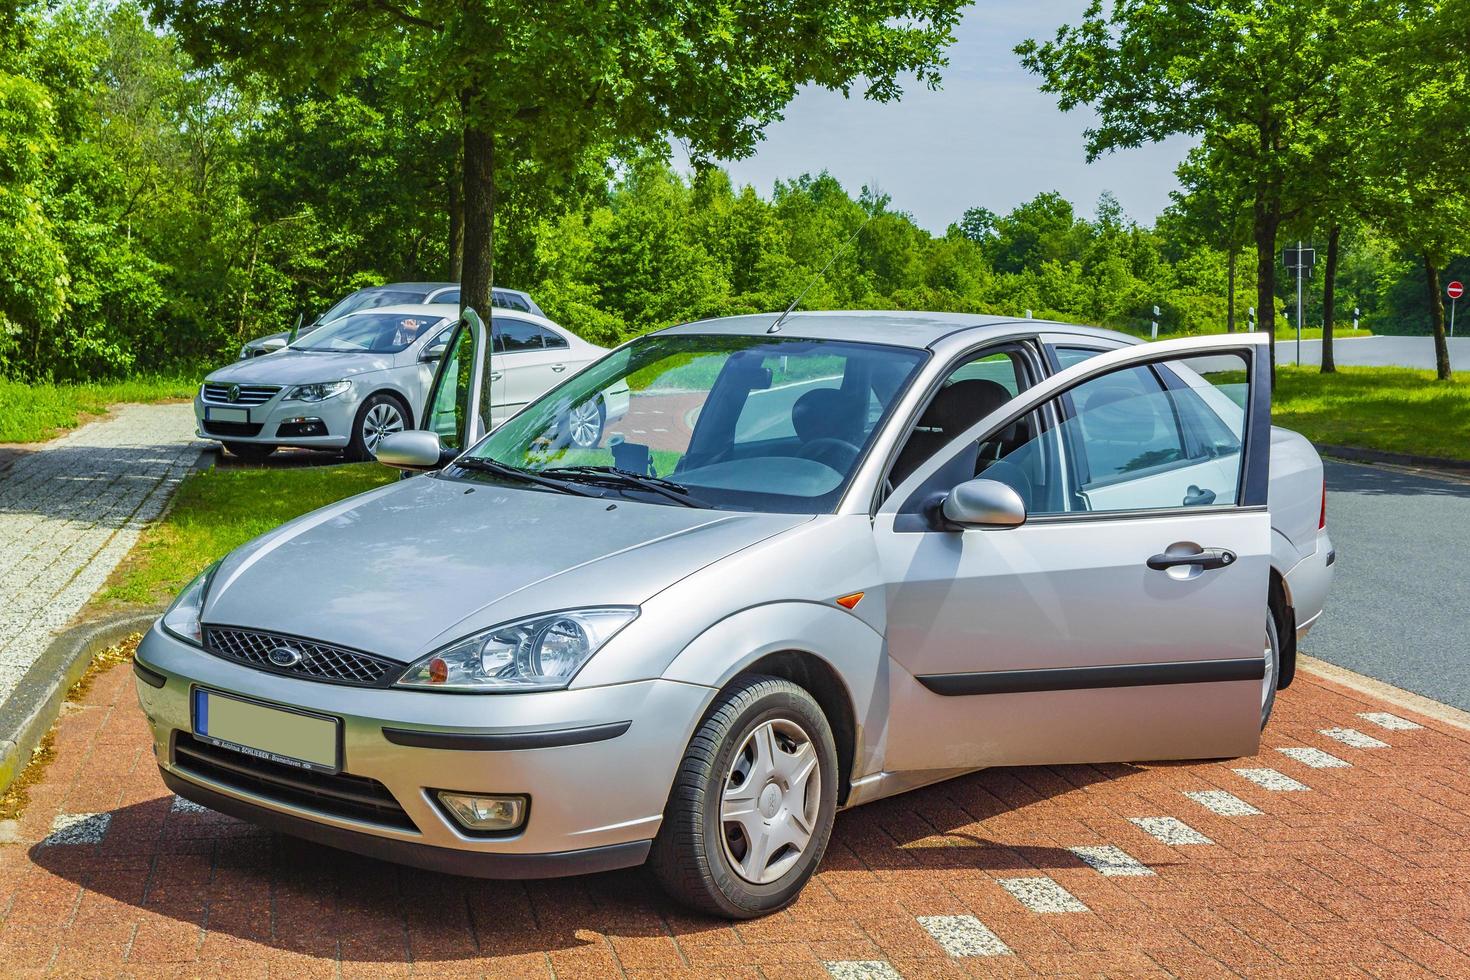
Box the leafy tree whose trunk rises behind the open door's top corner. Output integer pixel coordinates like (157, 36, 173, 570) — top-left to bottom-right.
(1017, 0, 1389, 373)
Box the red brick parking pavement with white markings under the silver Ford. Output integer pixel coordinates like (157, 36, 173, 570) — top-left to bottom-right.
(0, 655, 1470, 979)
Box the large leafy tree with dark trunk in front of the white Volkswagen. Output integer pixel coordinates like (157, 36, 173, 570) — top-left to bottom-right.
(150, 0, 964, 309)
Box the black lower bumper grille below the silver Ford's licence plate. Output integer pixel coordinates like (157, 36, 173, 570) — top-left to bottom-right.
(173, 732, 419, 833)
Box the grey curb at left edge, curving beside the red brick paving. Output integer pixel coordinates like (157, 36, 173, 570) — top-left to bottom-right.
(0, 611, 159, 792)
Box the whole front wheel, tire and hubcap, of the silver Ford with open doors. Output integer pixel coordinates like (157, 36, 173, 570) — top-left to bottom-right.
(648, 674, 838, 918)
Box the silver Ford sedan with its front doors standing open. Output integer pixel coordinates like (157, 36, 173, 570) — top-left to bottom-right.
(135, 313, 1333, 918)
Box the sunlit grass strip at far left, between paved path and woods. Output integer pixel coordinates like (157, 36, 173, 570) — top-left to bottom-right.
(0, 376, 198, 442)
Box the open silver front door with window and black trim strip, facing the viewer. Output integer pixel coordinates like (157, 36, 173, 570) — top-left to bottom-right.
(875, 338, 1270, 771)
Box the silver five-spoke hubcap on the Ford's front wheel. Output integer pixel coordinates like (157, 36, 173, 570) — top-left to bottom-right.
(720, 718, 822, 884)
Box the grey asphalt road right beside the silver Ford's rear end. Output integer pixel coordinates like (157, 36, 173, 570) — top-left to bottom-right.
(1302, 461, 1470, 711)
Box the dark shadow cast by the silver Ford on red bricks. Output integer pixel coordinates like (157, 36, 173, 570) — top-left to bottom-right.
(29, 765, 1157, 967)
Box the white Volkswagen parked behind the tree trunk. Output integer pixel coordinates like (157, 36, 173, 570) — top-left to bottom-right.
(194, 303, 619, 460)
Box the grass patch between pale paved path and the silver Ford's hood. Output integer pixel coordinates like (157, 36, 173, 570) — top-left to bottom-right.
(96, 463, 397, 608)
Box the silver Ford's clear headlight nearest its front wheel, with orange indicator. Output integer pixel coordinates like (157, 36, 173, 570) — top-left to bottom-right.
(395, 605, 638, 693)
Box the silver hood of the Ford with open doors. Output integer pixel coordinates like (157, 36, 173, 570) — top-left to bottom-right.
(203, 478, 811, 663)
